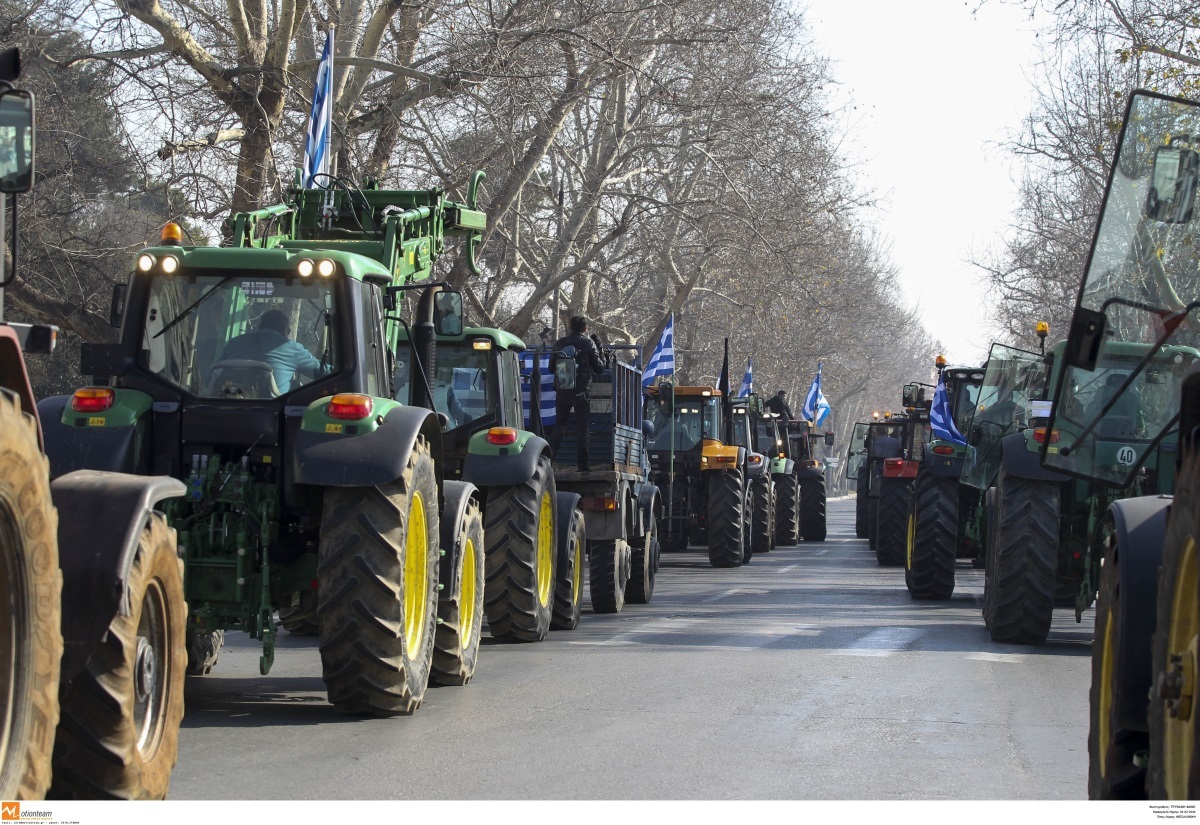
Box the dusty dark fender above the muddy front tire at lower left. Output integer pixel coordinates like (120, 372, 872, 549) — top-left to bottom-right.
(50, 470, 187, 682)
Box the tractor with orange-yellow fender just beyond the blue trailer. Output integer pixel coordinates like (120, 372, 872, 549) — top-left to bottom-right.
(646, 383, 752, 567)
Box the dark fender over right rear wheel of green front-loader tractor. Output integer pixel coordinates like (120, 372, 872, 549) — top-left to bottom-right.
(292, 407, 443, 487)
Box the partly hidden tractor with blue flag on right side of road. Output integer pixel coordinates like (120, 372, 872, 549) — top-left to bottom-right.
(905, 356, 984, 600)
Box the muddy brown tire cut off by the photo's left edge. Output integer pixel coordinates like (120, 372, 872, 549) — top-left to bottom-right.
(0, 392, 62, 800)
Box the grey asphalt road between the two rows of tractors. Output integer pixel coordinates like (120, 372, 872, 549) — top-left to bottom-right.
(170, 500, 1093, 800)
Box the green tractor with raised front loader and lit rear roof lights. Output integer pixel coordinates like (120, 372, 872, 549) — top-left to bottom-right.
(40, 174, 485, 715)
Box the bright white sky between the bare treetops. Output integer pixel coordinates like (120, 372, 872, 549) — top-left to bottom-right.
(797, 0, 1046, 363)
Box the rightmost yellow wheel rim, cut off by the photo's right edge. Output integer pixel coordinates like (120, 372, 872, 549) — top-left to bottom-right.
(1163, 537, 1200, 800)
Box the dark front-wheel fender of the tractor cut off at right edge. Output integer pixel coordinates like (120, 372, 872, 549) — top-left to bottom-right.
(1109, 495, 1171, 730)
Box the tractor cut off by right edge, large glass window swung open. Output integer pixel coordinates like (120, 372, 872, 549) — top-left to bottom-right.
(1039, 91, 1200, 800)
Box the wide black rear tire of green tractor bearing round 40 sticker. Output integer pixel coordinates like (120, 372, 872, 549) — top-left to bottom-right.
(983, 468, 1060, 644)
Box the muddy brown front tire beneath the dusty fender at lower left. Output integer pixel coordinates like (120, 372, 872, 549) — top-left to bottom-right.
(50, 512, 187, 800)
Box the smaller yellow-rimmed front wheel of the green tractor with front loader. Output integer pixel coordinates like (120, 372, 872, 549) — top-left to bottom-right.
(430, 500, 484, 685)
